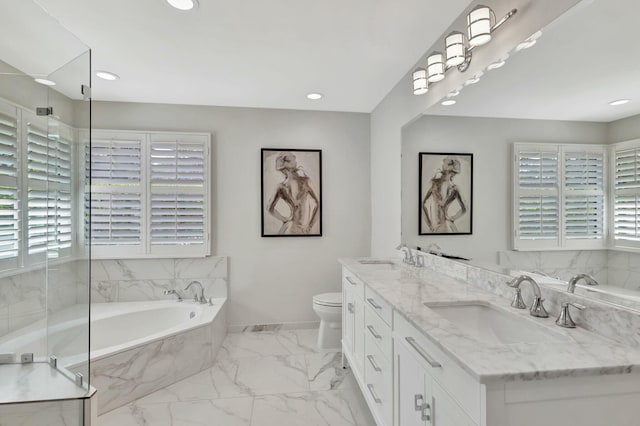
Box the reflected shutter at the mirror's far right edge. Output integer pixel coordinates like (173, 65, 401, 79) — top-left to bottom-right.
(613, 141, 640, 248)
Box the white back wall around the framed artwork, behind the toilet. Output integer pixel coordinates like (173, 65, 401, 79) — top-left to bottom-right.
(76, 102, 371, 325)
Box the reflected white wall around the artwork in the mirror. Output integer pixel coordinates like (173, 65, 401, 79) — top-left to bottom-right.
(402, 116, 607, 263)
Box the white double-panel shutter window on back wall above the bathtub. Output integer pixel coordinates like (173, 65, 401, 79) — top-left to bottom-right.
(86, 131, 210, 258)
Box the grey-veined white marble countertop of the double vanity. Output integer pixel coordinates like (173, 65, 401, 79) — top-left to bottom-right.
(340, 259, 640, 383)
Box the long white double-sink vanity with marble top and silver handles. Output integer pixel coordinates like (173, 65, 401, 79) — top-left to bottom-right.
(341, 259, 640, 426)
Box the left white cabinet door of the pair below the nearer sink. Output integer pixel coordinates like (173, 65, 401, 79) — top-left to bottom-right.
(395, 341, 430, 426)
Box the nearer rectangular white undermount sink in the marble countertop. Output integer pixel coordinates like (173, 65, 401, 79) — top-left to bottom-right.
(425, 302, 566, 344)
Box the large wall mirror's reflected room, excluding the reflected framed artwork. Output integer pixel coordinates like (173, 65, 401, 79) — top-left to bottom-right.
(402, 0, 640, 309)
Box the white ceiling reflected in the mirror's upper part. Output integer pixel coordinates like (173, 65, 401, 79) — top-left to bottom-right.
(427, 0, 640, 122)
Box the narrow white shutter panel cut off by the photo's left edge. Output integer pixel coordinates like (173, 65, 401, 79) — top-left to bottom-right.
(0, 103, 20, 269)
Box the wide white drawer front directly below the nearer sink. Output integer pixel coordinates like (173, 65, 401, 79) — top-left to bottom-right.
(393, 313, 482, 424)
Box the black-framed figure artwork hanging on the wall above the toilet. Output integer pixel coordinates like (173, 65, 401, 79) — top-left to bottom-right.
(261, 148, 322, 237)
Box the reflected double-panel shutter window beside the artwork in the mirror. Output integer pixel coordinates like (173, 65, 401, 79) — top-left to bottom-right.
(513, 144, 606, 250)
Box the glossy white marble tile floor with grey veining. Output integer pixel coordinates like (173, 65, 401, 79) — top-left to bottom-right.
(98, 329, 375, 426)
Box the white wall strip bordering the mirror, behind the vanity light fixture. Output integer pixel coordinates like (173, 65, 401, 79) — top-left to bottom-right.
(371, 0, 580, 256)
